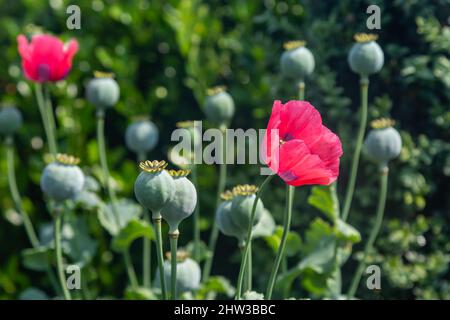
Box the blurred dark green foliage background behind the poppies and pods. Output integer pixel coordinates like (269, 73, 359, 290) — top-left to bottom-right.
(0, 0, 450, 299)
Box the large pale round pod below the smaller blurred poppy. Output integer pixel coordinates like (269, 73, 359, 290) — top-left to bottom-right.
(41, 154, 84, 202)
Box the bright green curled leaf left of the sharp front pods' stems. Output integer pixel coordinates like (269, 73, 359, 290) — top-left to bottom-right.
(112, 219, 155, 252)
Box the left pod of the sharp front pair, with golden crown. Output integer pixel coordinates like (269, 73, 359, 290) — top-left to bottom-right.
(134, 160, 175, 219)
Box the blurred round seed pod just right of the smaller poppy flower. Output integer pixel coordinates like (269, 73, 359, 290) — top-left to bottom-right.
(86, 71, 120, 110)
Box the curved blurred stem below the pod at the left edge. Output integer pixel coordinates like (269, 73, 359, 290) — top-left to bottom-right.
(6, 137, 39, 248)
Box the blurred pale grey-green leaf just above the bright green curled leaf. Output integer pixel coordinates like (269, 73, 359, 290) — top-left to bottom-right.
(98, 199, 143, 236)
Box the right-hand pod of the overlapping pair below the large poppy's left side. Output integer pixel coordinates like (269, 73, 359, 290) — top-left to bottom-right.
(230, 185, 264, 235)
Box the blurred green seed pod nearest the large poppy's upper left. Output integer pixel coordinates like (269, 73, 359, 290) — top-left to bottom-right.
(204, 87, 234, 126)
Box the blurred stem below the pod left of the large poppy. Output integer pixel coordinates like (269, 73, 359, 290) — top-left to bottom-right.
(203, 130, 227, 282)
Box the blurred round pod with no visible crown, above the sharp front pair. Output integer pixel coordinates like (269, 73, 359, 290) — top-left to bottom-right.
(125, 119, 159, 153)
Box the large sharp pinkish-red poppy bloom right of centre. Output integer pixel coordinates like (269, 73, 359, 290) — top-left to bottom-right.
(262, 101, 342, 186)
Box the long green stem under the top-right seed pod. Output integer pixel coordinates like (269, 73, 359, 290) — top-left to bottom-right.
(342, 77, 369, 221)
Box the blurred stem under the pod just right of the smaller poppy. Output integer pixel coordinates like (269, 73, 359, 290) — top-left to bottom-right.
(97, 111, 120, 226)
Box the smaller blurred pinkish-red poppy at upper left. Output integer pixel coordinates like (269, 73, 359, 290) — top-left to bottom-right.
(17, 34, 78, 82)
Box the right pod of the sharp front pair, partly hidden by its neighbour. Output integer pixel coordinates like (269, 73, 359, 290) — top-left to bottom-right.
(161, 170, 197, 234)
